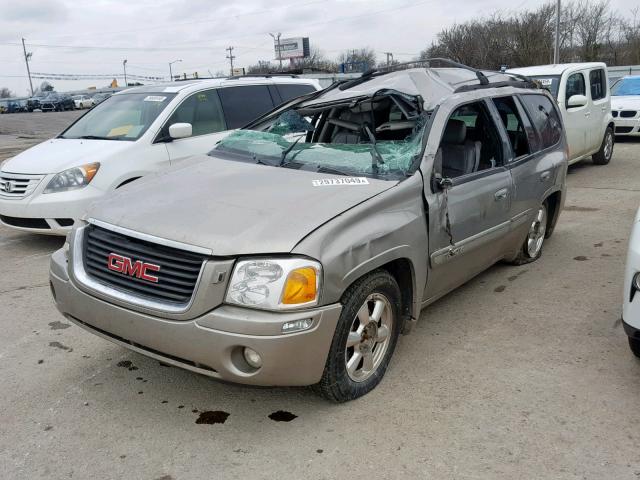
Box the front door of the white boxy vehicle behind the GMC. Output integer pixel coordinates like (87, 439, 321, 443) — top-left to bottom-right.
(561, 72, 591, 160)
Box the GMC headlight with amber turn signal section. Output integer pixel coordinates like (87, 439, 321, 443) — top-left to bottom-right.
(226, 258, 322, 310)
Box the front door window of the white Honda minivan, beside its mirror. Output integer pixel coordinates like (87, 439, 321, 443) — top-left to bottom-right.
(167, 90, 227, 137)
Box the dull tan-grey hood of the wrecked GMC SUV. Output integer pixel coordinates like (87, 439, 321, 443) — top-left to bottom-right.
(86, 153, 398, 256)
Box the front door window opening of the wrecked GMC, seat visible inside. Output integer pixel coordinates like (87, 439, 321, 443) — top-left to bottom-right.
(436, 102, 503, 178)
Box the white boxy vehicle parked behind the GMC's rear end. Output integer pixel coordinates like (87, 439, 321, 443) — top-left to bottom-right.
(507, 62, 614, 165)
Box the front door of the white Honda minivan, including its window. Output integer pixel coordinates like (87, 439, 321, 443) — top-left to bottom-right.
(159, 89, 227, 163)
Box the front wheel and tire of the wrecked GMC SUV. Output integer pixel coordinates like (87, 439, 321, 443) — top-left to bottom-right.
(315, 270, 401, 403)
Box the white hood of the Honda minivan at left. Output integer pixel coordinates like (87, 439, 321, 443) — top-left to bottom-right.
(2, 138, 132, 175)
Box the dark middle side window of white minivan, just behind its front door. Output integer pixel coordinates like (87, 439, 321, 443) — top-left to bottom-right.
(219, 85, 274, 129)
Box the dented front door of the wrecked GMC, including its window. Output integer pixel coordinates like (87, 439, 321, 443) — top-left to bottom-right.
(424, 102, 513, 300)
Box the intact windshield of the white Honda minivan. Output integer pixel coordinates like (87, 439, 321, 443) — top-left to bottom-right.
(58, 92, 175, 141)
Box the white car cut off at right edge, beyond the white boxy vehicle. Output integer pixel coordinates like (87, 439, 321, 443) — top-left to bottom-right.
(611, 75, 640, 136)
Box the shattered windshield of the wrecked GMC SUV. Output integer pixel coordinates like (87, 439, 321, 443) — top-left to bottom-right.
(216, 92, 429, 180)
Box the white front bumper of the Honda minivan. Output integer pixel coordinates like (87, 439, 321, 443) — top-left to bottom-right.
(0, 181, 105, 235)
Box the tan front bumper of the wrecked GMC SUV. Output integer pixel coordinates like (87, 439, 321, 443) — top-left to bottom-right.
(50, 250, 342, 386)
